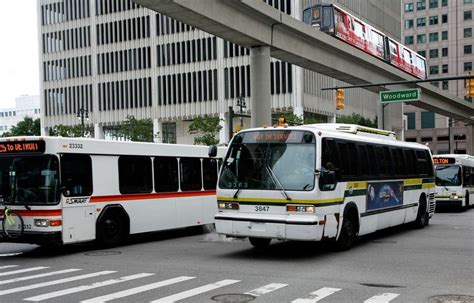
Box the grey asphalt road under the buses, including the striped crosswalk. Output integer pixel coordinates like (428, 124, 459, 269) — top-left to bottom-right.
(0, 209, 474, 303)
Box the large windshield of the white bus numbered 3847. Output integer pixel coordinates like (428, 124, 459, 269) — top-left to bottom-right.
(219, 130, 316, 191)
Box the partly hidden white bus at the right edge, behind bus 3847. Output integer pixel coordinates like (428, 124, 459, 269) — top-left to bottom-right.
(433, 154, 474, 209)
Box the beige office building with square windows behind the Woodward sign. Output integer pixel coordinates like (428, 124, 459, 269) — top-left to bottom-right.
(402, 0, 474, 154)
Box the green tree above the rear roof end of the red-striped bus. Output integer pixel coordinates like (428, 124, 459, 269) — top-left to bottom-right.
(188, 115, 222, 145)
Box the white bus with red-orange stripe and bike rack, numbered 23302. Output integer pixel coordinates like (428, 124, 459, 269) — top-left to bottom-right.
(0, 137, 224, 246)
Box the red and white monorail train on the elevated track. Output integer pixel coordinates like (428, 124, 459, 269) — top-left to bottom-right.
(303, 4, 427, 79)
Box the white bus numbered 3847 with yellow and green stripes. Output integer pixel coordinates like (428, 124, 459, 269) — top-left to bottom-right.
(215, 124, 435, 250)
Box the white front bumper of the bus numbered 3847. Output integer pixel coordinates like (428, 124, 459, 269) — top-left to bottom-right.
(215, 213, 325, 241)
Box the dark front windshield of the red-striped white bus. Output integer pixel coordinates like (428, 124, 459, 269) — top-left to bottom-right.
(0, 155, 59, 205)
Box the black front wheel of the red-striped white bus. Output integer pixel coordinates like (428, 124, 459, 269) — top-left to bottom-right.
(98, 212, 126, 247)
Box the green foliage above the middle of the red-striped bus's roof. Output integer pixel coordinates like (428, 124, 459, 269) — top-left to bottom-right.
(114, 115, 153, 142)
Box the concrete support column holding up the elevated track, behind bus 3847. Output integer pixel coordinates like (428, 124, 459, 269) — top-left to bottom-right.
(250, 46, 272, 127)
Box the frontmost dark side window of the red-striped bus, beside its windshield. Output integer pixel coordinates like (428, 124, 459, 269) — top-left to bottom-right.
(61, 154, 92, 197)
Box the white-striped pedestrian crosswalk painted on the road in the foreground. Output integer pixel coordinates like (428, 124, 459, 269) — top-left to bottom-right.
(0, 264, 400, 303)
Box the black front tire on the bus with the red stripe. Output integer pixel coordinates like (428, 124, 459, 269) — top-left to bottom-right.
(97, 207, 129, 247)
